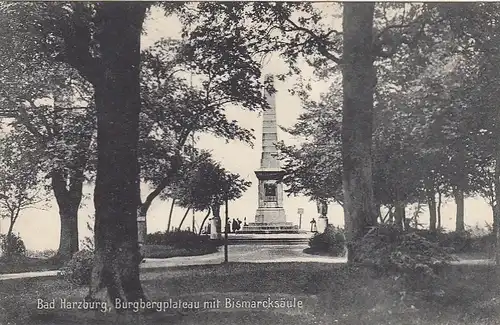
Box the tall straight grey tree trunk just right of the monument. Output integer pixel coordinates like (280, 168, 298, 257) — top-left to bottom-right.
(342, 2, 377, 262)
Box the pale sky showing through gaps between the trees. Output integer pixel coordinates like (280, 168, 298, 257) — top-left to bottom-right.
(0, 8, 492, 250)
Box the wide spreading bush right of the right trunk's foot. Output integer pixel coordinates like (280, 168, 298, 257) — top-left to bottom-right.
(354, 225, 455, 289)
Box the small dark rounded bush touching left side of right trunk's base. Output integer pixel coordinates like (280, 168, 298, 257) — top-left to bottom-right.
(309, 225, 346, 256)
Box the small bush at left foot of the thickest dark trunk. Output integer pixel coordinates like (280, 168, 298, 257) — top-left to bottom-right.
(59, 249, 94, 285)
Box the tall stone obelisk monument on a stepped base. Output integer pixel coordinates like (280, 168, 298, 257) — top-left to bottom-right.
(241, 76, 298, 233)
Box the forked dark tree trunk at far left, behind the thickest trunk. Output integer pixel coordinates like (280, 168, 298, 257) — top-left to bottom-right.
(51, 170, 83, 261)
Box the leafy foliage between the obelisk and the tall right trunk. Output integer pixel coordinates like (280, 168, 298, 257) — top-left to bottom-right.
(278, 81, 343, 203)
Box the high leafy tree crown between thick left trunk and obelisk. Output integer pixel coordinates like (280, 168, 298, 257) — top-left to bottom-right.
(140, 17, 276, 210)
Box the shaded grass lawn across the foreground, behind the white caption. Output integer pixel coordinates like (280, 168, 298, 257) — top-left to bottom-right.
(0, 263, 500, 325)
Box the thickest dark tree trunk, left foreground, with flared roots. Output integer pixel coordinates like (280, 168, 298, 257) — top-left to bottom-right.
(89, 2, 148, 303)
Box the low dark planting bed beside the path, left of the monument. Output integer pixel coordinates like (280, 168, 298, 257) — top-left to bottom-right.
(146, 230, 220, 250)
